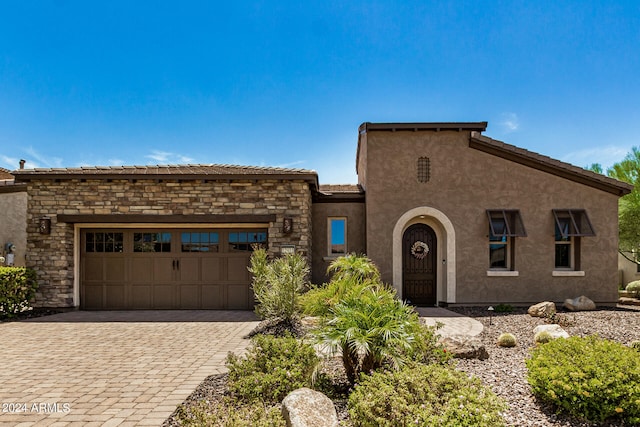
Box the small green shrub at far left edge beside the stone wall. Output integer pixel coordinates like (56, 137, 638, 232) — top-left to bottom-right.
(0, 267, 38, 317)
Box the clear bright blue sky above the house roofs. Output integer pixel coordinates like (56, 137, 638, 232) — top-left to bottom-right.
(0, 0, 640, 184)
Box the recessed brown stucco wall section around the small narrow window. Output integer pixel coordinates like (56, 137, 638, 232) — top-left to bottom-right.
(311, 203, 366, 285)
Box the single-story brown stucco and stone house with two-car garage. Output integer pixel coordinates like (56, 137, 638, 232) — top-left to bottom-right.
(12, 122, 632, 310)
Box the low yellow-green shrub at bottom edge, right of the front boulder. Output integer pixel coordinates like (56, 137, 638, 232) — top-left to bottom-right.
(349, 364, 506, 427)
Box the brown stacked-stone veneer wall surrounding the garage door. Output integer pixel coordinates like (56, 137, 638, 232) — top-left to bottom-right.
(26, 178, 311, 307)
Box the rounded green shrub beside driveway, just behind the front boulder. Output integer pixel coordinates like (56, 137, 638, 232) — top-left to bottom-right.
(227, 335, 319, 403)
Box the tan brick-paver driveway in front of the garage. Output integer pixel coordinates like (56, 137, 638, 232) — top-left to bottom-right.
(0, 311, 258, 426)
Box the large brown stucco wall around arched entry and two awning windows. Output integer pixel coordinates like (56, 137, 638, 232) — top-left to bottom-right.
(360, 131, 618, 304)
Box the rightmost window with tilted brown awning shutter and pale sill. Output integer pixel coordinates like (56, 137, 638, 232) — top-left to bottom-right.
(552, 209, 595, 271)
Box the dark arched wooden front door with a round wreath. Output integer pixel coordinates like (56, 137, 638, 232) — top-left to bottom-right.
(402, 224, 437, 306)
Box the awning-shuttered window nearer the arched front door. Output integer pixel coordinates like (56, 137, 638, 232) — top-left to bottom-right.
(487, 209, 527, 271)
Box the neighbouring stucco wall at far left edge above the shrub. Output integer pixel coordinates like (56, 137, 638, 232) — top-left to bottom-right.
(0, 191, 27, 267)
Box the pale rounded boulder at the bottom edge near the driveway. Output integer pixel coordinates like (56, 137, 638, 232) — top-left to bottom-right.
(282, 387, 338, 427)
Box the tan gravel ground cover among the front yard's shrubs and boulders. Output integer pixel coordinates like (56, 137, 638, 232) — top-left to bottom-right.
(163, 306, 640, 427)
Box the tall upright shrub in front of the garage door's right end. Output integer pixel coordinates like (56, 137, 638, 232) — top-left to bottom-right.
(249, 248, 309, 322)
